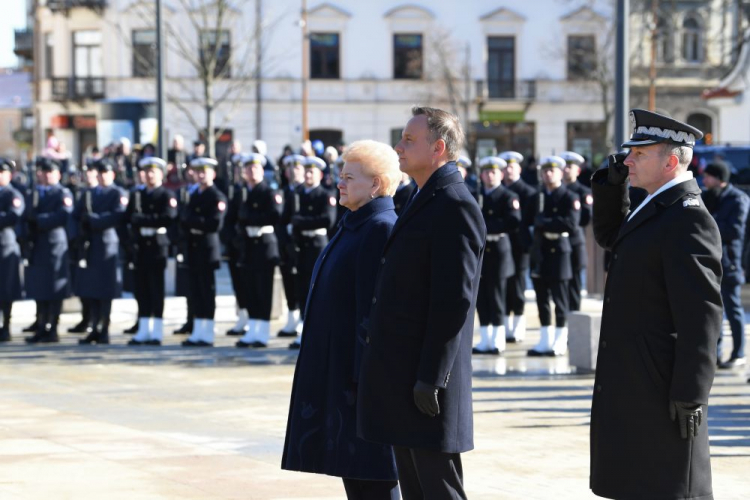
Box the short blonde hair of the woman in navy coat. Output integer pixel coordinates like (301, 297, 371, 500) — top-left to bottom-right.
(341, 140, 401, 196)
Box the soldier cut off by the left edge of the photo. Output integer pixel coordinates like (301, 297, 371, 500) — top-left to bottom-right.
(0, 158, 25, 342)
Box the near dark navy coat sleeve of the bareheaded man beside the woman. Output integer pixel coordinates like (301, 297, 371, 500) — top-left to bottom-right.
(417, 193, 486, 388)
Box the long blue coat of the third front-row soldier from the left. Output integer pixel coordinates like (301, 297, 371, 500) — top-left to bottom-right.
(73, 185, 128, 300)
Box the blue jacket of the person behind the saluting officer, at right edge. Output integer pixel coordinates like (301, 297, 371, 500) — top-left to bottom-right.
(711, 184, 750, 286)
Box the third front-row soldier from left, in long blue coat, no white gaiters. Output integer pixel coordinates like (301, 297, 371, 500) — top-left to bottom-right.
(73, 158, 128, 344)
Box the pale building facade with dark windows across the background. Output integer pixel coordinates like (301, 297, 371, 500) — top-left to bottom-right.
(25, 0, 748, 166)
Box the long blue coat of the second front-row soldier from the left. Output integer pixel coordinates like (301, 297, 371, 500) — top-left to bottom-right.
(22, 184, 73, 300)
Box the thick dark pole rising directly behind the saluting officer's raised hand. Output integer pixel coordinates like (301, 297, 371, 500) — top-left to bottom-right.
(615, 0, 630, 148)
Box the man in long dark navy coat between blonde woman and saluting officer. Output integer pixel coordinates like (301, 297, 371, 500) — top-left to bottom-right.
(357, 107, 486, 500)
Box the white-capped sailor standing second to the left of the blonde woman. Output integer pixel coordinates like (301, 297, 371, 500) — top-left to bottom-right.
(276, 155, 305, 337)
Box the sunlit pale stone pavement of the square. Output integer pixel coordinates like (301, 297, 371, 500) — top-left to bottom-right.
(0, 297, 750, 500)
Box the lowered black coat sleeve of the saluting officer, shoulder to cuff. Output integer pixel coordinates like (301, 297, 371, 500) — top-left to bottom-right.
(662, 207, 722, 404)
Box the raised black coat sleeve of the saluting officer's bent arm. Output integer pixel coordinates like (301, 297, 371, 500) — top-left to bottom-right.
(591, 168, 630, 250)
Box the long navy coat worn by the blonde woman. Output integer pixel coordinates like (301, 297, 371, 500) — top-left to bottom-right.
(281, 197, 396, 480)
